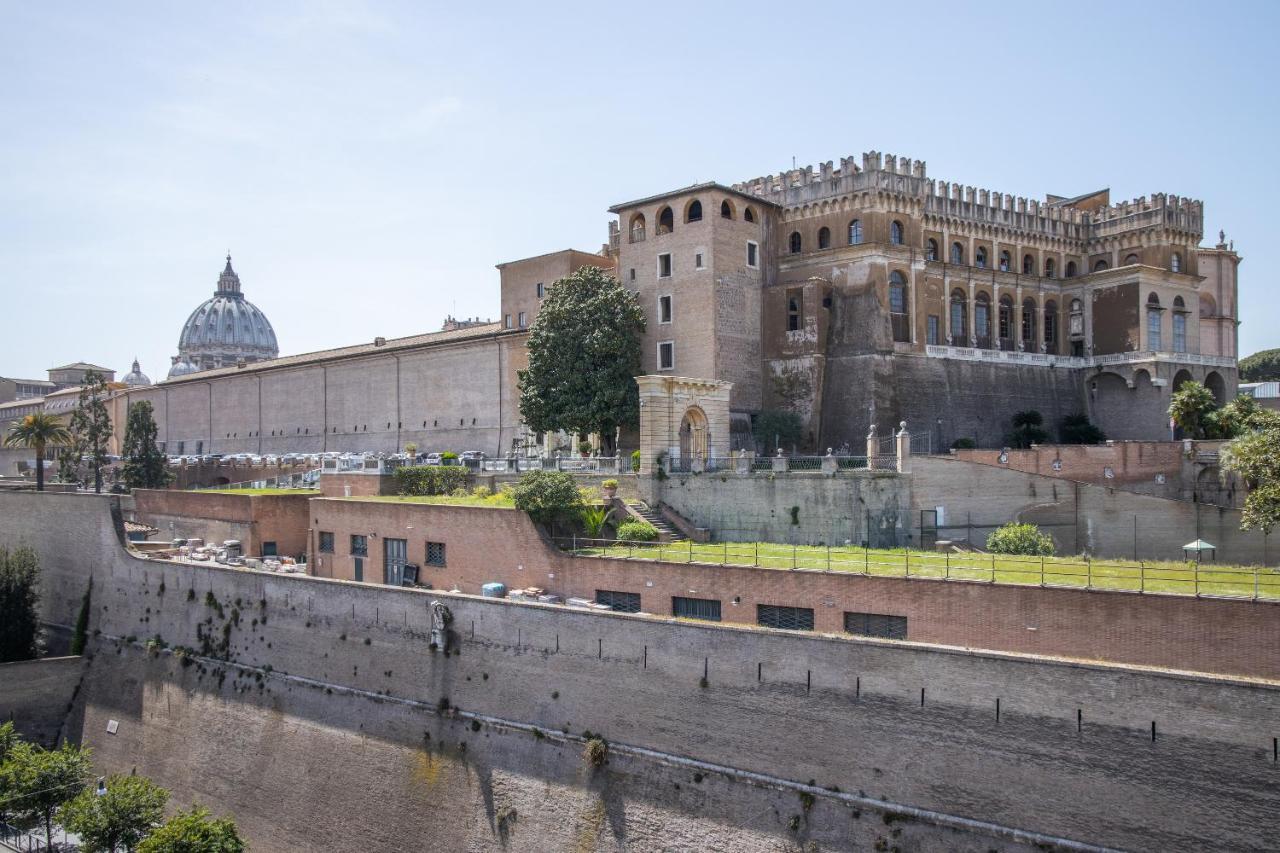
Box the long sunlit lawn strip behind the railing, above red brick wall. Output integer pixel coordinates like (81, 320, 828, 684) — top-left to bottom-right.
(576, 542, 1280, 601)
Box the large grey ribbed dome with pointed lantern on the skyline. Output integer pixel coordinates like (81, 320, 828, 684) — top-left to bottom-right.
(169, 255, 280, 377)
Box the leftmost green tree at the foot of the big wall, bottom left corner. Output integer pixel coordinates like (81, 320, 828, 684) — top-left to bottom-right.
(4, 742, 91, 847)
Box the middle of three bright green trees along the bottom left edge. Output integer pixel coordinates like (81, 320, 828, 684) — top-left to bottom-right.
(59, 776, 169, 853)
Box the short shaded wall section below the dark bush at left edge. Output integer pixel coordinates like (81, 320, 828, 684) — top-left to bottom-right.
(0, 656, 84, 747)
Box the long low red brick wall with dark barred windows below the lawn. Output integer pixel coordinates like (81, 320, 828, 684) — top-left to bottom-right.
(311, 500, 1280, 678)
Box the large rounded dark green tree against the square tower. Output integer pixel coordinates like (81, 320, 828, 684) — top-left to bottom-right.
(518, 266, 645, 455)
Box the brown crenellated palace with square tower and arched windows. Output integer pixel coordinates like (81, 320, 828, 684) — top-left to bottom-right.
(609, 152, 1240, 448)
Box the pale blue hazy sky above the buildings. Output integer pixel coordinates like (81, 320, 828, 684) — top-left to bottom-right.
(0, 0, 1280, 379)
